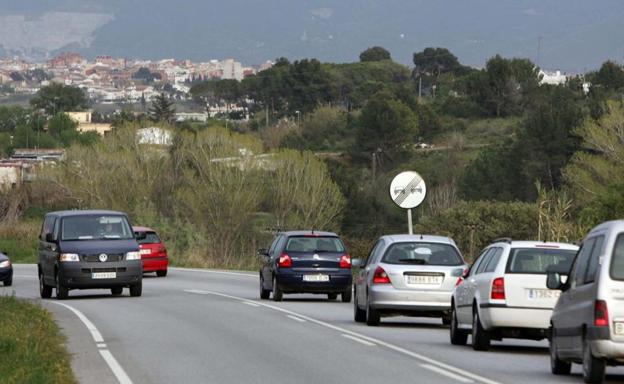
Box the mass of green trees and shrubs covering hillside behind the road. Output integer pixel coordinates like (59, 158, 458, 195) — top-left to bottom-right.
(0, 47, 624, 268)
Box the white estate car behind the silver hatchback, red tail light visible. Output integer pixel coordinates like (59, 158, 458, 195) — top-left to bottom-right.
(450, 239, 578, 350)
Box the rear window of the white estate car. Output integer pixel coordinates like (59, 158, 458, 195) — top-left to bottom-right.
(507, 248, 576, 274)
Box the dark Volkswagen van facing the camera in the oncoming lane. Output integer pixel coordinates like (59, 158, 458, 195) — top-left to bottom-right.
(38, 210, 143, 300)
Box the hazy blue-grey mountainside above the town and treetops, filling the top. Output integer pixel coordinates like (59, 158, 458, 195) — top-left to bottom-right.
(0, 0, 624, 72)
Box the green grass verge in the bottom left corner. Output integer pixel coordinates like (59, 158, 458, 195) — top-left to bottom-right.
(0, 296, 76, 384)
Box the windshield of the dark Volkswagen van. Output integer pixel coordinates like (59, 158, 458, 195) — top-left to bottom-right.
(61, 215, 134, 241)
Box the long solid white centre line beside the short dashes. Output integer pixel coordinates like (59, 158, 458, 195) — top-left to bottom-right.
(184, 290, 500, 384)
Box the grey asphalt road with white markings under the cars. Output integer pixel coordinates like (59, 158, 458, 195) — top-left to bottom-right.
(0, 265, 624, 384)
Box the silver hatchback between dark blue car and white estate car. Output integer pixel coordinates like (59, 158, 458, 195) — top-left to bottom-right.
(353, 235, 467, 325)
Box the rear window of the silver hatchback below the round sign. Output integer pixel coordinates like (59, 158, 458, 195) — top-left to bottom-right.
(381, 242, 464, 265)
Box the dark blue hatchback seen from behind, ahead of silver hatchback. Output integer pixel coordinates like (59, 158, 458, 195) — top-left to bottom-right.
(258, 231, 352, 303)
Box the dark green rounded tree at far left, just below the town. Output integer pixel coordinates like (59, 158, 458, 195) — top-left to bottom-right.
(30, 84, 89, 116)
